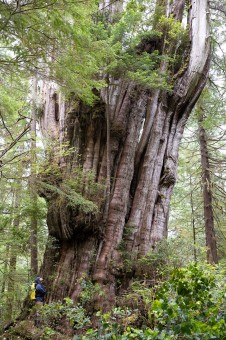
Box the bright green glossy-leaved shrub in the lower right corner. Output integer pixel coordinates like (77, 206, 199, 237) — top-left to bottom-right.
(150, 264, 226, 339)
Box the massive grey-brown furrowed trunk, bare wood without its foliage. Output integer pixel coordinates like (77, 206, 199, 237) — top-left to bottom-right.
(38, 0, 210, 308)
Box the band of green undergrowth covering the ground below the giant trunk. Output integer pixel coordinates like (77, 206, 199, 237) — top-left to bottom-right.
(6, 261, 226, 340)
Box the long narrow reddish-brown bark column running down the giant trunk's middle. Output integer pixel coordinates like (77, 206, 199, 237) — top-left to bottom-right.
(94, 88, 146, 281)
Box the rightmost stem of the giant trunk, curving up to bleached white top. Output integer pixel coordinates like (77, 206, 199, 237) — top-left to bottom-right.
(125, 2, 210, 256)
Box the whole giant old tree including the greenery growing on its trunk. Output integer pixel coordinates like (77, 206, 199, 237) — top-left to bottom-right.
(34, 0, 210, 307)
